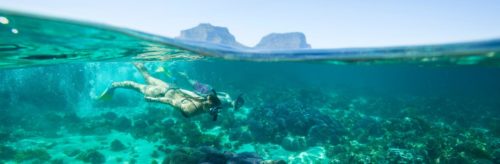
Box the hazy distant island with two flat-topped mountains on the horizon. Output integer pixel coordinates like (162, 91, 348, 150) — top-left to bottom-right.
(177, 23, 311, 50)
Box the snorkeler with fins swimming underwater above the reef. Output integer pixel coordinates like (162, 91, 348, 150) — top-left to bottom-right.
(99, 63, 244, 121)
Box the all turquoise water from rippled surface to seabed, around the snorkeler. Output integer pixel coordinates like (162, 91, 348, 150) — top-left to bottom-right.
(0, 11, 500, 163)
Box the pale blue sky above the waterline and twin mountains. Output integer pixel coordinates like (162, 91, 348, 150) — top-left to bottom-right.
(0, 0, 500, 48)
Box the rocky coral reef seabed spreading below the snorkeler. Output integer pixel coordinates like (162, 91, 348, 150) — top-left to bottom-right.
(0, 82, 500, 163)
